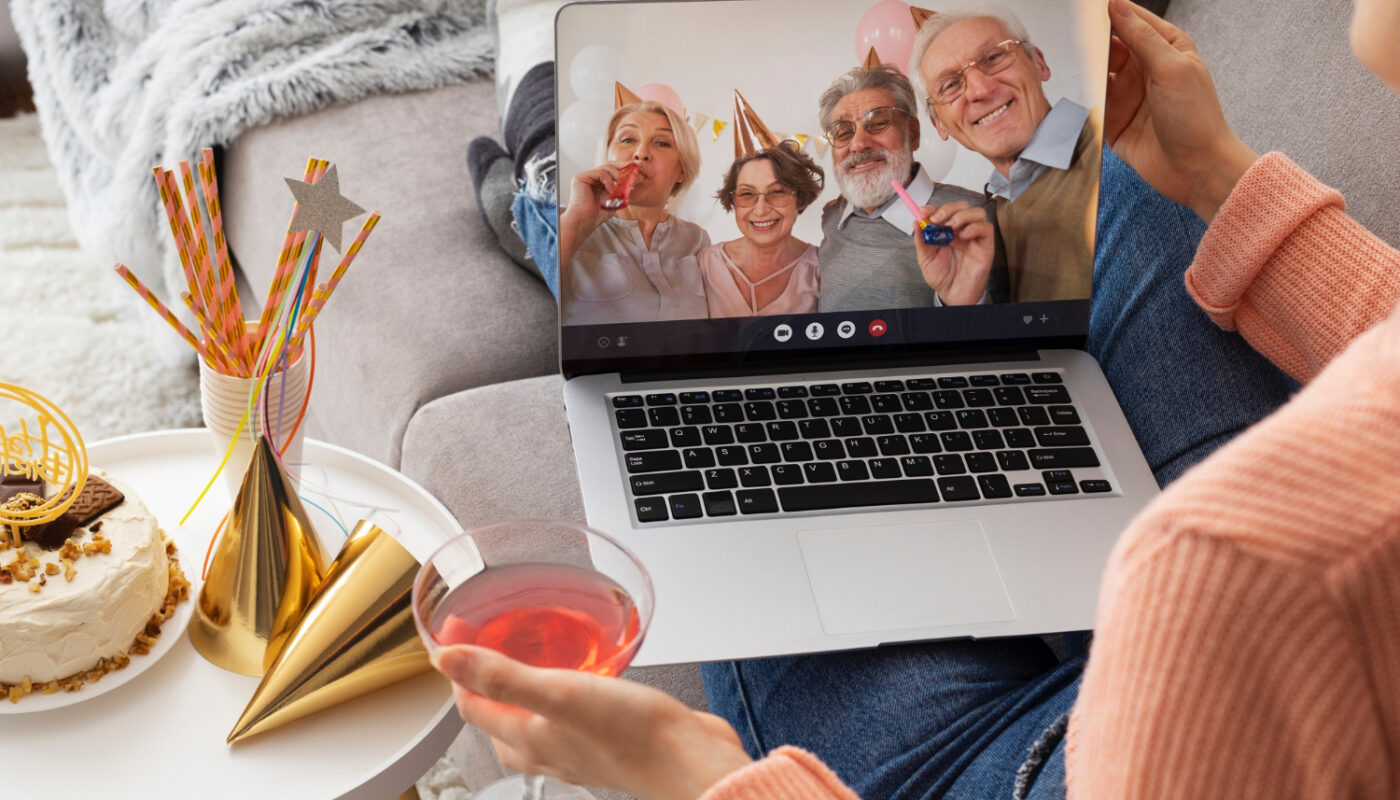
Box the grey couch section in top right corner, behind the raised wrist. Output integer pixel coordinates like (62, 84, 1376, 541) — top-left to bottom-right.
(1166, 0, 1400, 247)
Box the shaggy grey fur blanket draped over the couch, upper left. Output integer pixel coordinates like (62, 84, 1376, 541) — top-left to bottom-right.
(10, 0, 494, 325)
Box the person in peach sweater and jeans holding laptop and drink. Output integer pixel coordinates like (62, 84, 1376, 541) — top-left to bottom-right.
(437, 0, 1400, 800)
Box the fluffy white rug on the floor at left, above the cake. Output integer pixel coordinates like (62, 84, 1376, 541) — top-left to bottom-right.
(0, 113, 469, 800)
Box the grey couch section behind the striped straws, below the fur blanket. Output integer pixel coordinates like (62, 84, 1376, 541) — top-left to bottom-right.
(220, 80, 559, 467)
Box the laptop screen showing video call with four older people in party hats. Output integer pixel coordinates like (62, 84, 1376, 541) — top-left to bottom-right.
(556, 0, 1109, 374)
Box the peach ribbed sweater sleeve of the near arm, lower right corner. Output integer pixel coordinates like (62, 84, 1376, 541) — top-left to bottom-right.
(1067, 298, 1400, 800)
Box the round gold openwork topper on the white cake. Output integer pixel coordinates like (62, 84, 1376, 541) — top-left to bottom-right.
(0, 382, 88, 545)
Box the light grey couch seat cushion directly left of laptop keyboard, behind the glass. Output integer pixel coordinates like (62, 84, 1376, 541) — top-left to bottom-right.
(402, 375, 706, 800)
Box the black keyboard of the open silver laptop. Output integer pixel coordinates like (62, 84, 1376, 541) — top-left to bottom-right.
(609, 371, 1113, 524)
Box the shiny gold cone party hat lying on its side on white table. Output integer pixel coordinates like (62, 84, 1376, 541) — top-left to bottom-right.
(228, 520, 431, 744)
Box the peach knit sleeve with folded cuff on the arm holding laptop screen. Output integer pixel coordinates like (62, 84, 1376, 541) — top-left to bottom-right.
(1186, 153, 1400, 381)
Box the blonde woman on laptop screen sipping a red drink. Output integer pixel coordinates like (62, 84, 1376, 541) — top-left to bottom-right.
(559, 102, 710, 325)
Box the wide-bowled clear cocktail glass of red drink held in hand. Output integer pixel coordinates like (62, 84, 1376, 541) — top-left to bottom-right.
(413, 520, 654, 800)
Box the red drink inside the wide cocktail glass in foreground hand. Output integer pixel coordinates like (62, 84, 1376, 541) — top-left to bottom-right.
(431, 563, 641, 675)
